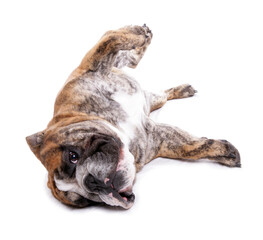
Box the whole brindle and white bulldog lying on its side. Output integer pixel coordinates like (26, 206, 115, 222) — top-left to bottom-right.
(26, 24, 241, 209)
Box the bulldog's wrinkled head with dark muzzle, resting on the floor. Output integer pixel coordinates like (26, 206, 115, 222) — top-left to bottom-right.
(27, 120, 135, 209)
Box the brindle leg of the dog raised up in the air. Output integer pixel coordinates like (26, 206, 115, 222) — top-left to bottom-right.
(78, 25, 152, 75)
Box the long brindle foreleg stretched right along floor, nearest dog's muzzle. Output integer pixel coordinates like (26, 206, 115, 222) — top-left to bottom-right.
(148, 123, 241, 167)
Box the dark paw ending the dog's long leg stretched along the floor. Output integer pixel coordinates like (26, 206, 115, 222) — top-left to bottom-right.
(211, 140, 241, 167)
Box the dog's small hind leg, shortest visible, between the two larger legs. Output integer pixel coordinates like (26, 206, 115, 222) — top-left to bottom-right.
(146, 84, 197, 112)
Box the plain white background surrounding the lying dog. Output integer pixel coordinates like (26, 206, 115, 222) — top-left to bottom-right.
(0, 0, 263, 240)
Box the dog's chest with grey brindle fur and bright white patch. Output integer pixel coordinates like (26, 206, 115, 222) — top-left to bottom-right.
(72, 71, 150, 142)
